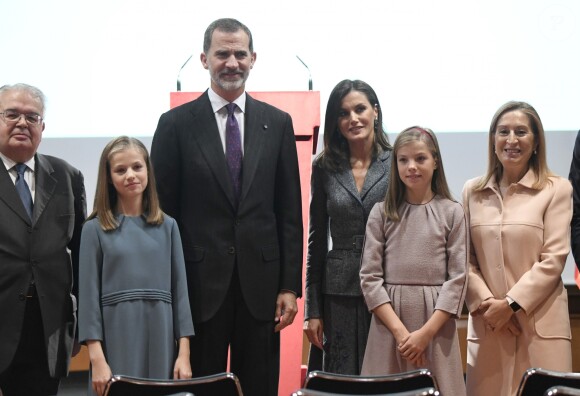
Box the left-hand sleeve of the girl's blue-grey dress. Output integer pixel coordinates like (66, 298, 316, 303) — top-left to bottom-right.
(78, 220, 103, 344)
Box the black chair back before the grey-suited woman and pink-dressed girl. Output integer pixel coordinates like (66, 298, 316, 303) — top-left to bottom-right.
(303, 369, 439, 395)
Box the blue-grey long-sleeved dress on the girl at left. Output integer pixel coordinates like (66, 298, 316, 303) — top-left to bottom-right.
(79, 215, 194, 379)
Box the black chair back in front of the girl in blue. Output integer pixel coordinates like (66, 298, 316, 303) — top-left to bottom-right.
(105, 373, 243, 396)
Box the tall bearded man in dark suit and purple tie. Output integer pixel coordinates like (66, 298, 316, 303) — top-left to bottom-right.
(151, 19, 303, 396)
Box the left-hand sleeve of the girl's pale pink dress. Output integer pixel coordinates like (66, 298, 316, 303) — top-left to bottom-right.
(360, 202, 391, 311)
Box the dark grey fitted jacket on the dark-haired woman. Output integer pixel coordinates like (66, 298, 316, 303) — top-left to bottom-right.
(305, 151, 392, 319)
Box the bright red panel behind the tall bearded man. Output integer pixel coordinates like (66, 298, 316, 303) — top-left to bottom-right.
(170, 91, 320, 395)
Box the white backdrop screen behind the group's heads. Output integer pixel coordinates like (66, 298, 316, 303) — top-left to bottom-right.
(0, 0, 580, 137)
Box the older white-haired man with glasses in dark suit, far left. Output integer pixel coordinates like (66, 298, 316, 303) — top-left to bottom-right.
(0, 84, 86, 396)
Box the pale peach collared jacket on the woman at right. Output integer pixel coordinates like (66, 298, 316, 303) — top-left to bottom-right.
(463, 170, 572, 339)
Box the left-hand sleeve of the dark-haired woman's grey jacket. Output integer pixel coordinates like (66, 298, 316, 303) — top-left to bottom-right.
(304, 162, 328, 320)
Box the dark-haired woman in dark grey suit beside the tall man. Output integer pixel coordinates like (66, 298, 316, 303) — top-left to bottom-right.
(304, 80, 392, 375)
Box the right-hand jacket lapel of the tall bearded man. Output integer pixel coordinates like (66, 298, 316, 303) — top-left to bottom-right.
(240, 93, 268, 202)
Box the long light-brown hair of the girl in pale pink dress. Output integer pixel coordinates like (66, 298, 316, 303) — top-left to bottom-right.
(385, 126, 454, 221)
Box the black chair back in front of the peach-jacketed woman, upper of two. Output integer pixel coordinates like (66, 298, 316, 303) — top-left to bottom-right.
(517, 368, 580, 396)
